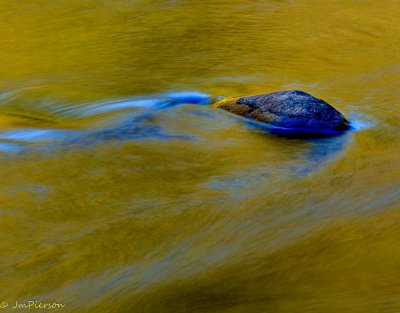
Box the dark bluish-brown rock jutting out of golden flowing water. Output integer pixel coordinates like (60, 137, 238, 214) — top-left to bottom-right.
(214, 90, 349, 131)
